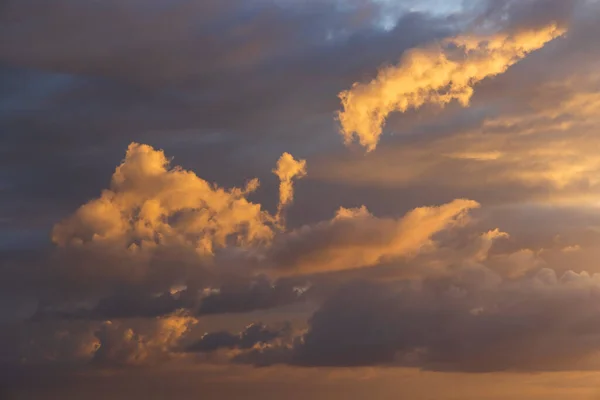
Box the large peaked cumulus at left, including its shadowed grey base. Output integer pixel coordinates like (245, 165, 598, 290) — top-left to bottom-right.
(41, 143, 296, 298)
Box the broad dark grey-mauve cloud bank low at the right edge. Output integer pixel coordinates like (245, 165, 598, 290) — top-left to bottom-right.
(238, 268, 600, 372)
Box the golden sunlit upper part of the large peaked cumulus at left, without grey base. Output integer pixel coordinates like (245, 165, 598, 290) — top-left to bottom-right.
(52, 143, 273, 255)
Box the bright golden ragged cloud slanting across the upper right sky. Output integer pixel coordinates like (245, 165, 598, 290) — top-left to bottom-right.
(338, 24, 565, 151)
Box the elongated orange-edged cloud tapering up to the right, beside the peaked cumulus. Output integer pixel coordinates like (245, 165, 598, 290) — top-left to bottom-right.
(265, 199, 479, 275)
